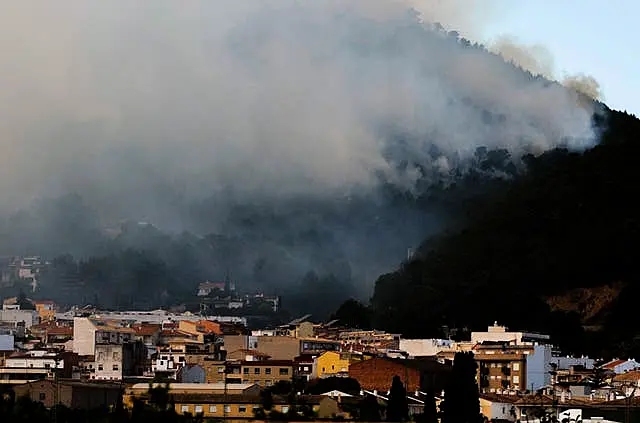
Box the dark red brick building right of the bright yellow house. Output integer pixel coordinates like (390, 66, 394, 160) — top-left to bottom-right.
(349, 358, 420, 392)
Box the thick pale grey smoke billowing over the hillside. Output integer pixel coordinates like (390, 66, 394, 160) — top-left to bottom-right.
(0, 0, 592, 225)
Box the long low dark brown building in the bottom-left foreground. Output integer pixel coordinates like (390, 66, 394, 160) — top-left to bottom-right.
(13, 380, 124, 410)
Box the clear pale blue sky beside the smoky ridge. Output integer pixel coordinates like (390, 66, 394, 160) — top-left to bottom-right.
(483, 0, 640, 116)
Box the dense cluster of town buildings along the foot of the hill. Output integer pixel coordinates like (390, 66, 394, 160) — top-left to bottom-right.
(0, 299, 640, 421)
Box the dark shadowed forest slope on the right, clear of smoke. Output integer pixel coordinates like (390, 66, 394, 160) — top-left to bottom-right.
(372, 111, 640, 356)
